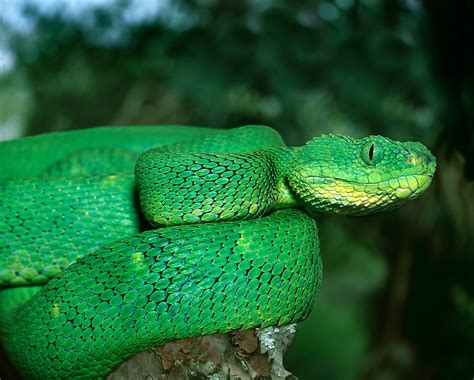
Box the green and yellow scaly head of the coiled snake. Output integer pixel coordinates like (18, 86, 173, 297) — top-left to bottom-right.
(288, 135, 436, 215)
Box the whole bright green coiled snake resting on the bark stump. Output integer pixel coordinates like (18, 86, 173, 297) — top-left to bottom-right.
(0, 126, 436, 378)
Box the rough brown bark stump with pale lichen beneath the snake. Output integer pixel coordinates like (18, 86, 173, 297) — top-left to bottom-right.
(108, 324, 296, 380)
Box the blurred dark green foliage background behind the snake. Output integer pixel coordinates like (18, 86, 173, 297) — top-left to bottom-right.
(0, 0, 474, 380)
